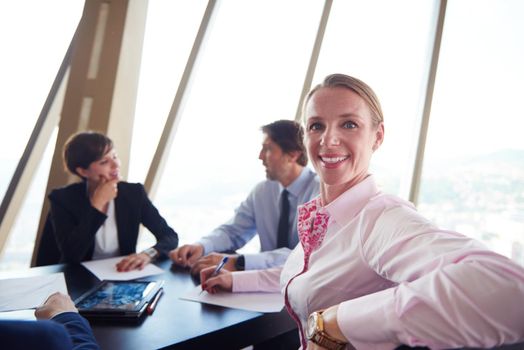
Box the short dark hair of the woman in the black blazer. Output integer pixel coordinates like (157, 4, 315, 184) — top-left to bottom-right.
(63, 131, 113, 177)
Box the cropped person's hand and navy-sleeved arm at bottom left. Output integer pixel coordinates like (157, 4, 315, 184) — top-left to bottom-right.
(0, 293, 99, 350)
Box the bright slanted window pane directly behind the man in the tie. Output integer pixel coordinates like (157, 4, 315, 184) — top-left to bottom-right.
(150, 0, 323, 252)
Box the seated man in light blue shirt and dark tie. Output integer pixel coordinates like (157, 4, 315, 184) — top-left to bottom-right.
(169, 120, 319, 274)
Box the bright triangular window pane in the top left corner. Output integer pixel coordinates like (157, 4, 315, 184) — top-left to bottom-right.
(0, 0, 84, 197)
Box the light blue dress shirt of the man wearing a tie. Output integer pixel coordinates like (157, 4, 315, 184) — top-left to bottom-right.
(198, 167, 319, 270)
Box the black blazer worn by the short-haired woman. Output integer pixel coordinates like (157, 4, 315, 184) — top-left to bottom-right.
(48, 182, 178, 263)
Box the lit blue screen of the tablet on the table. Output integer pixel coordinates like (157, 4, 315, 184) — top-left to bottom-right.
(76, 281, 156, 310)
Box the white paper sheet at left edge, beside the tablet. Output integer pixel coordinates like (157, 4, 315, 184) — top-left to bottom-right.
(0, 272, 68, 311)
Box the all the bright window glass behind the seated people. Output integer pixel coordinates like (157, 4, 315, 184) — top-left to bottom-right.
(0, 0, 524, 269)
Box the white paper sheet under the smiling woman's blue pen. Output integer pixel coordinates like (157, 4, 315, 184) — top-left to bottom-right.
(180, 286, 284, 312)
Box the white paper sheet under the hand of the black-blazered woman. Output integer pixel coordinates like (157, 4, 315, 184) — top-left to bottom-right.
(82, 256, 164, 281)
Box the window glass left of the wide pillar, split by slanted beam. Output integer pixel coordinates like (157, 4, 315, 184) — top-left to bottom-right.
(0, 0, 84, 270)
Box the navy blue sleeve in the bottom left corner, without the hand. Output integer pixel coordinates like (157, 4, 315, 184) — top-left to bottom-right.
(0, 312, 100, 350)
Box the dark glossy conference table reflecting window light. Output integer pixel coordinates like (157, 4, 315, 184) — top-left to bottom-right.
(3, 260, 296, 350)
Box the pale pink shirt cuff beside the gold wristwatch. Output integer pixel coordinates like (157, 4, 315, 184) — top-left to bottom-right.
(337, 288, 400, 349)
